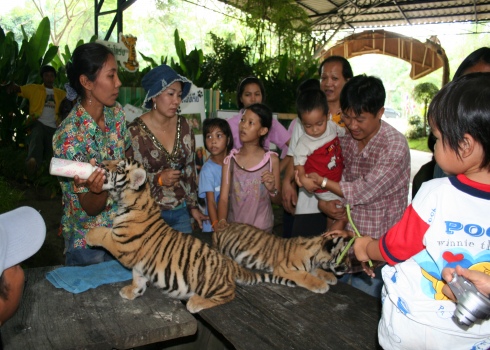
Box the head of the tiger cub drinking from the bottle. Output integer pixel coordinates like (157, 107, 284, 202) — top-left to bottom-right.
(102, 158, 146, 195)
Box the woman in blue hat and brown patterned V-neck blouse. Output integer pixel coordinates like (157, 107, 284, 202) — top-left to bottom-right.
(126, 64, 207, 233)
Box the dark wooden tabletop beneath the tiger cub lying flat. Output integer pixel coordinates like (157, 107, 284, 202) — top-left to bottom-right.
(199, 283, 381, 350)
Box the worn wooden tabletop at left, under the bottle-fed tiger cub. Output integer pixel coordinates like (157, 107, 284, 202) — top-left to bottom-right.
(2, 267, 197, 350)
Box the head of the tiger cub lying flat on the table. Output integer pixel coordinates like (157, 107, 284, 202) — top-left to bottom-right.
(320, 237, 350, 276)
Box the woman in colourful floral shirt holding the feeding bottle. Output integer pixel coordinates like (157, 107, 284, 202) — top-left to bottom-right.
(53, 43, 131, 265)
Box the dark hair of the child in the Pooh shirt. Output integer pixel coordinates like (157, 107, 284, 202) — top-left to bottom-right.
(427, 73, 490, 169)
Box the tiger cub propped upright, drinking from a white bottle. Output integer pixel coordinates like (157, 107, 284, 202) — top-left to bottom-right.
(85, 159, 294, 313)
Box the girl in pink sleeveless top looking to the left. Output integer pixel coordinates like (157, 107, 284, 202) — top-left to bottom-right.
(218, 103, 281, 232)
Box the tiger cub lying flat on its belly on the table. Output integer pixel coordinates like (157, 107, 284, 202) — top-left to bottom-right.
(213, 223, 348, 293)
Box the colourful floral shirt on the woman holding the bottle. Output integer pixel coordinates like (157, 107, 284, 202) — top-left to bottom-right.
(53, 102, 131, 250)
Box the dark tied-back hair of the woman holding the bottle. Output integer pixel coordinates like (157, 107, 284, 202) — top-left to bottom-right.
(66, 43, 114, 97)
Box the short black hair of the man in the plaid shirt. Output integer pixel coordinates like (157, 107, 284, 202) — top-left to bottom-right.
(340, 74, 386, 116)
